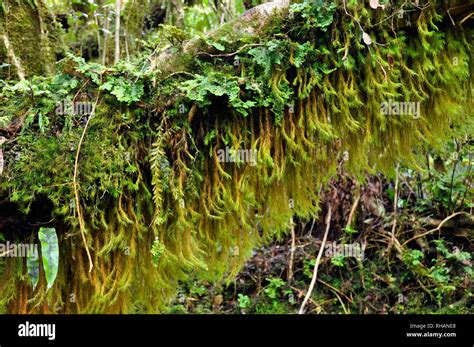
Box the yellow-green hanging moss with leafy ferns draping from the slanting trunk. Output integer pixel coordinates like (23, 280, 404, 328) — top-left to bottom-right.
(0, 2, 472, 313)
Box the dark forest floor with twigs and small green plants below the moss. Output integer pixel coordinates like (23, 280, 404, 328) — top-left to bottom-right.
(169, 177, 474, 314)
